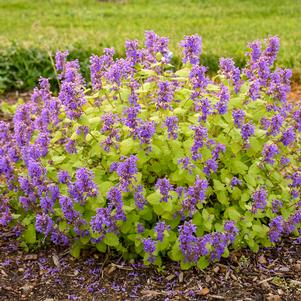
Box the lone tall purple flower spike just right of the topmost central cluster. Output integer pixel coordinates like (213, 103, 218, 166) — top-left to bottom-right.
(180, 34, 202, 65)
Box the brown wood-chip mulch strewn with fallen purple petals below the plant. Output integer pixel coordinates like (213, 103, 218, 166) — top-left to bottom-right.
(0, 231, 301, 301)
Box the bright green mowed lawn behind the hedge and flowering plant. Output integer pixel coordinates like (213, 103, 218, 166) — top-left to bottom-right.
(0, 0, 301, 69)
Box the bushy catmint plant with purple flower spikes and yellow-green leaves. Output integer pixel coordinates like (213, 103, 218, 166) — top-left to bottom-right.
(0, 31, 301, 269)
